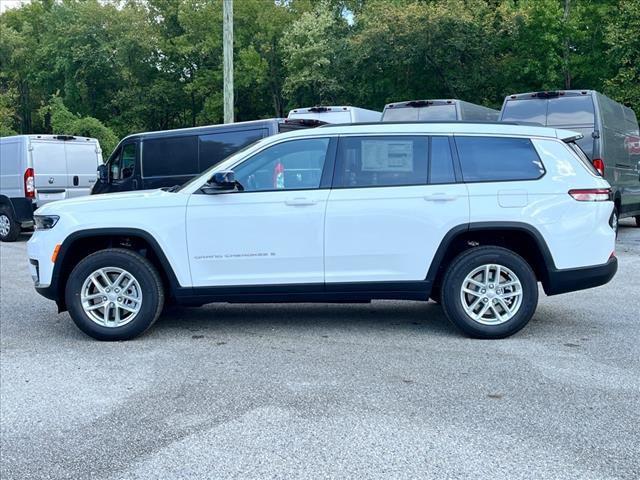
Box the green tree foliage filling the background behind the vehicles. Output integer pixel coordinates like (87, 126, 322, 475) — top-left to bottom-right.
(0, 0, 640, 150)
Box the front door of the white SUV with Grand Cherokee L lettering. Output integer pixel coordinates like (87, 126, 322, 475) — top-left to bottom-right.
(187, 138, 331, 287)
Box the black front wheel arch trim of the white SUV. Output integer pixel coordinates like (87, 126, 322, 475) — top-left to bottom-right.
(45, 228, 180, 312)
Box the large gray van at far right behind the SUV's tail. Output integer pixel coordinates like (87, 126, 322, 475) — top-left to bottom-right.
(500, 90, 640, 229)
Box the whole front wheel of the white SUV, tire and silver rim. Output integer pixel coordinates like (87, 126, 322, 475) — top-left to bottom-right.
(65, 248, 164, 340)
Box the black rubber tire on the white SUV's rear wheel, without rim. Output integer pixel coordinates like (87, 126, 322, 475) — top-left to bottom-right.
(442, 246, 538, 339)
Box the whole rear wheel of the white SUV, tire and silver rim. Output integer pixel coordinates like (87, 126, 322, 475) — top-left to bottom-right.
(442, 247, 538, 338)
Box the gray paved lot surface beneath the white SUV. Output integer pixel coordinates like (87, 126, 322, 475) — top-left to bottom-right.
(0, 221, 640, 480)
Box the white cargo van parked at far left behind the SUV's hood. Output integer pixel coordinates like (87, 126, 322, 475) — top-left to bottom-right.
(0, 135, 102, 242)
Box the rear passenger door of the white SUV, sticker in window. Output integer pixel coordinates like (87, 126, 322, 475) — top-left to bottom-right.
(325, 135, 469, 288)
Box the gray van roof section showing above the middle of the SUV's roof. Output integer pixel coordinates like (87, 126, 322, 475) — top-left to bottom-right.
(381, 98, 500, 122)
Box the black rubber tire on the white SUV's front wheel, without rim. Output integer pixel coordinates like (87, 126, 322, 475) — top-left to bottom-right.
(65, 248, 164, 341)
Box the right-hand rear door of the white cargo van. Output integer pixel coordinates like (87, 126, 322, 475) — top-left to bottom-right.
(65, 140, 102, 198)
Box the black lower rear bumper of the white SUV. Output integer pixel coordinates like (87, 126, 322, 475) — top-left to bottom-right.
(544, 257, 618, 295)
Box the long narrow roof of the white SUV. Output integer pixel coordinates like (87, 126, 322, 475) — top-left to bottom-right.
(278, 122, 581, 140)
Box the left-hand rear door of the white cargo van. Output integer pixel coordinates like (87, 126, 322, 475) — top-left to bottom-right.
(29, 139, 68, 205)
